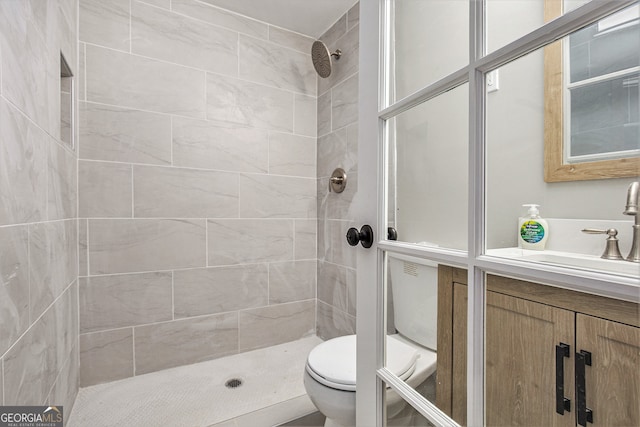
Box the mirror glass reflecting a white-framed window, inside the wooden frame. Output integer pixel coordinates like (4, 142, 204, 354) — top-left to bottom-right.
(562, 4, 640, 163)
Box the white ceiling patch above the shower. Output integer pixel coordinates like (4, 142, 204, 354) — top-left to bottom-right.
(202, 0, 357, 38)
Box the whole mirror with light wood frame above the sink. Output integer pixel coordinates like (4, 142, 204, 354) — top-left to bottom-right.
(544, 0, 640, 182)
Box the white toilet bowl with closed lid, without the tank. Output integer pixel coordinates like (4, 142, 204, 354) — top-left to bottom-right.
(304, 334, 436, 427)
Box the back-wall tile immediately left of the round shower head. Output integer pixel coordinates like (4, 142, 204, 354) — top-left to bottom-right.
(239, 34, 316, 95)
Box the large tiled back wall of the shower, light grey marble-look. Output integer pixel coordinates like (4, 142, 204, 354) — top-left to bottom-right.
(79, 0, 318, 386)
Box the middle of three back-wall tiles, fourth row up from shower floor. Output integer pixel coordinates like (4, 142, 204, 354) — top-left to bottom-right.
(133, 166, 238, 218)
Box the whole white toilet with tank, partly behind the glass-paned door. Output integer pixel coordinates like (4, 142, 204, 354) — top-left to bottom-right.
(304, 254, 438, 427)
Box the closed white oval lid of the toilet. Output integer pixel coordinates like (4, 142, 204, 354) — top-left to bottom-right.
(307, 335, 418, 391)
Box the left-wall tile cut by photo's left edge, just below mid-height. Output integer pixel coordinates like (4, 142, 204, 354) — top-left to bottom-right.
(0, 226, 29, 354)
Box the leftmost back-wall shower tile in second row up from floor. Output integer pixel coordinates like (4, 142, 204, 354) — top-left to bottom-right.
(80, 272, 173, 333)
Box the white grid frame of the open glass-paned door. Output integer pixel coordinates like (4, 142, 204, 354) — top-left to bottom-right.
(358, 0, 640, 426)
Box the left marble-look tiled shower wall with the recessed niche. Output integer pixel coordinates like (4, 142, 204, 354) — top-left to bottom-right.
(0, 0, 79, 414)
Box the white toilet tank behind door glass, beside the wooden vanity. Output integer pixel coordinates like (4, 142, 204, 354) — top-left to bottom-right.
(388, 253, 438, 351)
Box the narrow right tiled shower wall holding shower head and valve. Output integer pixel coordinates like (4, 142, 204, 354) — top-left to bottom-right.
(316, 3, 360, 339)
